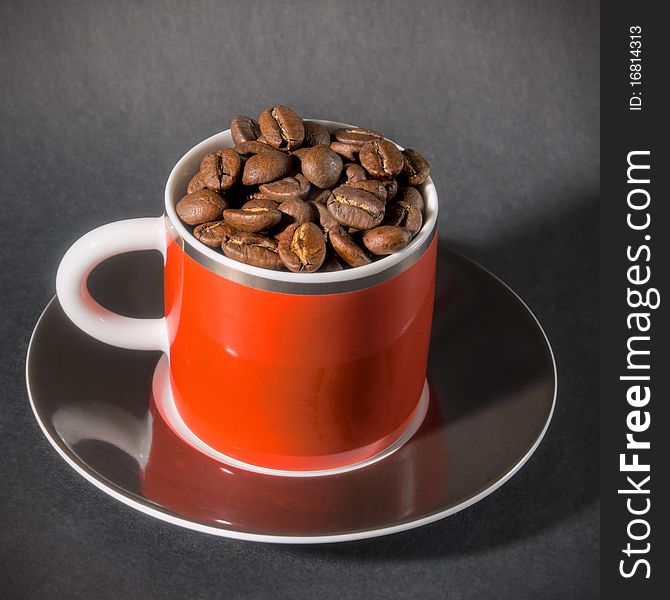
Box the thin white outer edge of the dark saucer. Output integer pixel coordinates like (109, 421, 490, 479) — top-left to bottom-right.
(25, 255, 558, 544)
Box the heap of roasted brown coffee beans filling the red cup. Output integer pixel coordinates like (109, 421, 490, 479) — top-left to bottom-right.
(176, 105, 430, 273)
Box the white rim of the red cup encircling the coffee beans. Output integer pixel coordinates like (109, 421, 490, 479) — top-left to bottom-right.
(165, 119, 438, 285)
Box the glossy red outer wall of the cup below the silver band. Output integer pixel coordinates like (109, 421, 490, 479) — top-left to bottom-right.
(165, 239, 437, 470)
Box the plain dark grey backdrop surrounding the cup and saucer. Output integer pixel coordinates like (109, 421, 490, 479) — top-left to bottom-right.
(0, 0, 599, 599)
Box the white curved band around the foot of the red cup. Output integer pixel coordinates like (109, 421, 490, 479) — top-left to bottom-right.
(151, 354, 430, 478)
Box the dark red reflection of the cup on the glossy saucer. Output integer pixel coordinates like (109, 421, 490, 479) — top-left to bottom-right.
(139, 389, 448, 535)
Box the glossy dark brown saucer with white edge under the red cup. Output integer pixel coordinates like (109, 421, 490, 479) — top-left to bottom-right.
(26, 251, 556, 543)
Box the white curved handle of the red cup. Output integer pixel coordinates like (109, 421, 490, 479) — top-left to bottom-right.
(56, 217, 170, 354)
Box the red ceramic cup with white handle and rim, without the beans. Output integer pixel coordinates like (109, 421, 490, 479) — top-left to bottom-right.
(56, 121, 438, 472)
